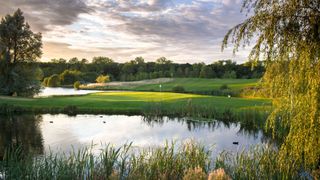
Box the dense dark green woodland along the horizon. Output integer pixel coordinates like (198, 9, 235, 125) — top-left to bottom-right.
(38, 57, 265, 85)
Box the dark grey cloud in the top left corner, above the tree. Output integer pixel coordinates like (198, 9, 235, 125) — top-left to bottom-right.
(0, 0, 92, 32)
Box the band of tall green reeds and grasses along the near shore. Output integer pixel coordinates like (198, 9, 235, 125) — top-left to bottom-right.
(0, 142, 310, 180)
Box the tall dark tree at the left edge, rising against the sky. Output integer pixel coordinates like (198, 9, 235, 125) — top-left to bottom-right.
(0, 9, 42, 96)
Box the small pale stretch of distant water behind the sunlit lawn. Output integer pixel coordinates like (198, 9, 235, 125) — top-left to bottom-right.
(36, 87, 101, 97)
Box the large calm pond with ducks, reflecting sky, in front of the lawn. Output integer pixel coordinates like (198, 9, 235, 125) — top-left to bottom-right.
(0, 114, 267, 155)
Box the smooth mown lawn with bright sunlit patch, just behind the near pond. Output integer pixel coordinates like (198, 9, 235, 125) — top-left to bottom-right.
(0, 92, 270, 112)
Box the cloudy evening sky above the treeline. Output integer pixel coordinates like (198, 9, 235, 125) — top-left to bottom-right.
(0, 0, 249, 63)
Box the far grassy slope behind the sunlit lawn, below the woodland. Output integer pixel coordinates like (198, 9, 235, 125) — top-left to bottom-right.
(82, 78, 258, 96)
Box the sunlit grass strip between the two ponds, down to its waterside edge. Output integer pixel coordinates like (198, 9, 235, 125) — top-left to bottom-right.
(0, 92, 270, 115)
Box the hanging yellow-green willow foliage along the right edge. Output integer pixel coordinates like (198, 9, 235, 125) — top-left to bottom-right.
(222, 0, 320, 174)
